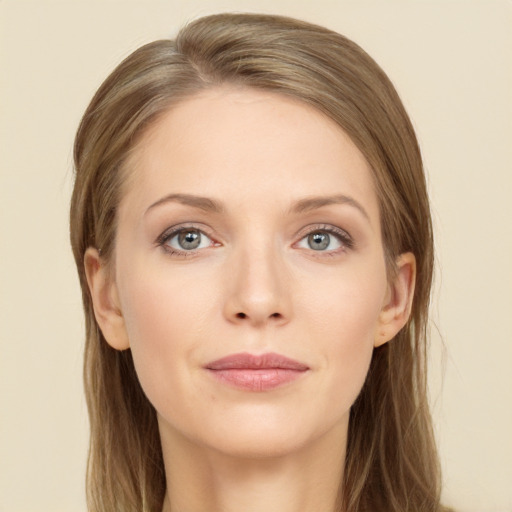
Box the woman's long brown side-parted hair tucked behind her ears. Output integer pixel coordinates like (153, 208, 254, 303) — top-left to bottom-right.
(71, 14, 443, 512)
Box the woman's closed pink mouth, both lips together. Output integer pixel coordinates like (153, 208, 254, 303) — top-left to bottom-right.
(205, 353, 309, 391)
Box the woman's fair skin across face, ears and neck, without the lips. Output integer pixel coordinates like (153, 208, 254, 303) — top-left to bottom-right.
(85, 87, 415, 512)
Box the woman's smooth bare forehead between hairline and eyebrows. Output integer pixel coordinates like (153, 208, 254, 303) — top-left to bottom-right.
(122, 87, 378, 224)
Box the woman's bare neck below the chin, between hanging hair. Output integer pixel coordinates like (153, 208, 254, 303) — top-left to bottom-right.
(161, 418, 346, 512)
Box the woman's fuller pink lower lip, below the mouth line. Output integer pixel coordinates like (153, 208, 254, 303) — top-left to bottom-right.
(209, 368, 307, 391)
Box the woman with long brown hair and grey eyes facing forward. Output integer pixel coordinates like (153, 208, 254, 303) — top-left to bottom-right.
(71, 14, 443, 512)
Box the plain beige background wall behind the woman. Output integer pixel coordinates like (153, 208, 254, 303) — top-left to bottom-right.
(0, 0, 512, 512)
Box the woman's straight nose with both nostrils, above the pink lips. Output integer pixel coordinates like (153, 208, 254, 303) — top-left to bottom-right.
(224, 241, 292, 327)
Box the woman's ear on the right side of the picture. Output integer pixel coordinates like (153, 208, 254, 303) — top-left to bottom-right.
(374, 252, 416, 347)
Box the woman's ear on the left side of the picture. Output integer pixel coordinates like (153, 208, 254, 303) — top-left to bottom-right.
(84, 247, 130, 350)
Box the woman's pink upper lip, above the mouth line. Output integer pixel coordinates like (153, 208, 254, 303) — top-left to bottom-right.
(205, 352, 309, 371)
